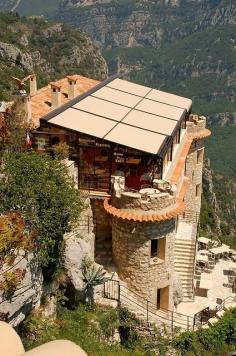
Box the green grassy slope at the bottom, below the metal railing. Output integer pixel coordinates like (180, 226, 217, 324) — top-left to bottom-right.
(21, 304, 160, 356)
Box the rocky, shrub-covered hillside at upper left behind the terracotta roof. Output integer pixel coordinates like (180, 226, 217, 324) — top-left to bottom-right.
(0, 14, 107, 100)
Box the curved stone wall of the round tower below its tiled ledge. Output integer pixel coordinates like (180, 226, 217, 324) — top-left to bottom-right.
(112, 218, 175, 309)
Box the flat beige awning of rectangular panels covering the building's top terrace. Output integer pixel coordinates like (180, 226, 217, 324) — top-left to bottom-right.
(45, 79, 192, 154)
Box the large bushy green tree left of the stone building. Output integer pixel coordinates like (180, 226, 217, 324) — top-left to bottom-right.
(0, 152, 82, 278)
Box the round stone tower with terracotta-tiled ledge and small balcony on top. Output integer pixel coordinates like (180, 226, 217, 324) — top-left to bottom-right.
(104, 181, 184, 309)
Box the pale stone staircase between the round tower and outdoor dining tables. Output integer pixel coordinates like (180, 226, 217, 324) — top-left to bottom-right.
(174, 239, 196, 302)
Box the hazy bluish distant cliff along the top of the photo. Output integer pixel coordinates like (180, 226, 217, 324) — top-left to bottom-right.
(57, 0, 236, 48)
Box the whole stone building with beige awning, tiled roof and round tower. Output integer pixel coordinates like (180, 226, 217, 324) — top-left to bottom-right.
(24, 76, 210, 310)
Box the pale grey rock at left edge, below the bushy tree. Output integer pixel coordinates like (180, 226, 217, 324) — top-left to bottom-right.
(0, 251, 43, 326)
